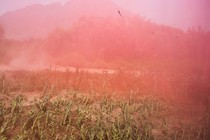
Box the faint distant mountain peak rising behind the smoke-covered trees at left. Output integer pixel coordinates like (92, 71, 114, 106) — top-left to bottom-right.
(0, 0, 125, 39)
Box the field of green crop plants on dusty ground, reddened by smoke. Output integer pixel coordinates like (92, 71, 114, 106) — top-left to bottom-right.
(0, 69, 210, 140)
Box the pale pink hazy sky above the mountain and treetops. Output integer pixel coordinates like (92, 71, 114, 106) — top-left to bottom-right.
(0, 0, 210, 30)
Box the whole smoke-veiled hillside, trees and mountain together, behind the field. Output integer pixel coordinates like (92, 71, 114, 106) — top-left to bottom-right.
(0, 0, 210, 73)
